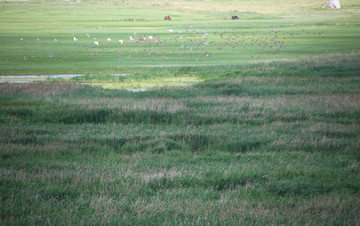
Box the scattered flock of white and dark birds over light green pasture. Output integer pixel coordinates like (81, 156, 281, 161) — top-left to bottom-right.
(14, 25, 324, 63)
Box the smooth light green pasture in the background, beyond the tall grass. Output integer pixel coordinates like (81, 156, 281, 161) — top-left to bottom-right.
(0, 1, 360, 75)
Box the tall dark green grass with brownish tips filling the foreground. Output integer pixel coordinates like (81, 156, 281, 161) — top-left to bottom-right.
(0, 57, 360, 222)
